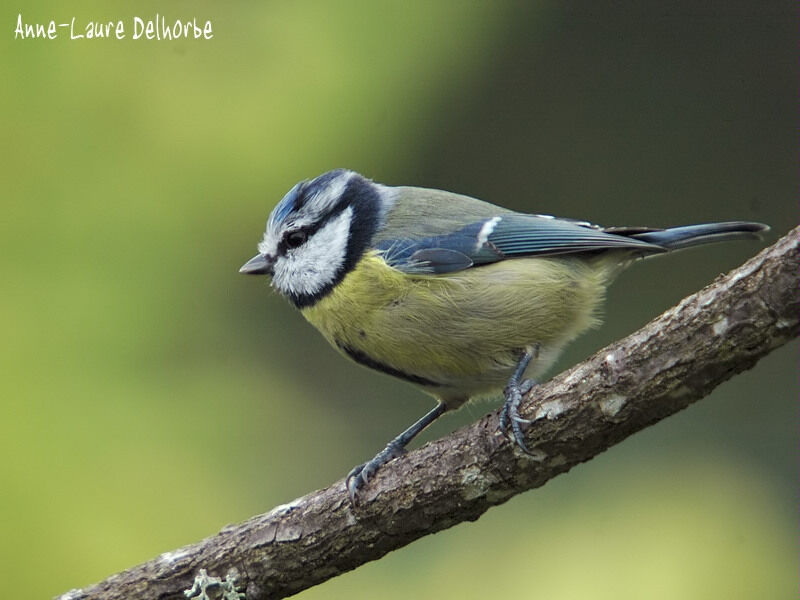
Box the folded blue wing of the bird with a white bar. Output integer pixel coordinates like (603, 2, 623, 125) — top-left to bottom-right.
(376, 213, 666, 274)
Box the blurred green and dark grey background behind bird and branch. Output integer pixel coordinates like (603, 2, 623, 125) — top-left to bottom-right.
(0, 0, 798, 600)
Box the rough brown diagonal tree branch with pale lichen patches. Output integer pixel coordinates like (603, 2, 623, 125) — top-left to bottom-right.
(60, 227, 800, 600)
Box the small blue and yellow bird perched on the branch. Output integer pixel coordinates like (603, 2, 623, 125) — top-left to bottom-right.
(240, 169, 768, 501)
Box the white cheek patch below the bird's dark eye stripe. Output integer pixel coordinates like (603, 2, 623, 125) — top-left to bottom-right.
(272, 207, 353, 295)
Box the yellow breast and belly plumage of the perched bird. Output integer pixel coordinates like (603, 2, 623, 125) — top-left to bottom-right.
(302, 253, 610, 408)
